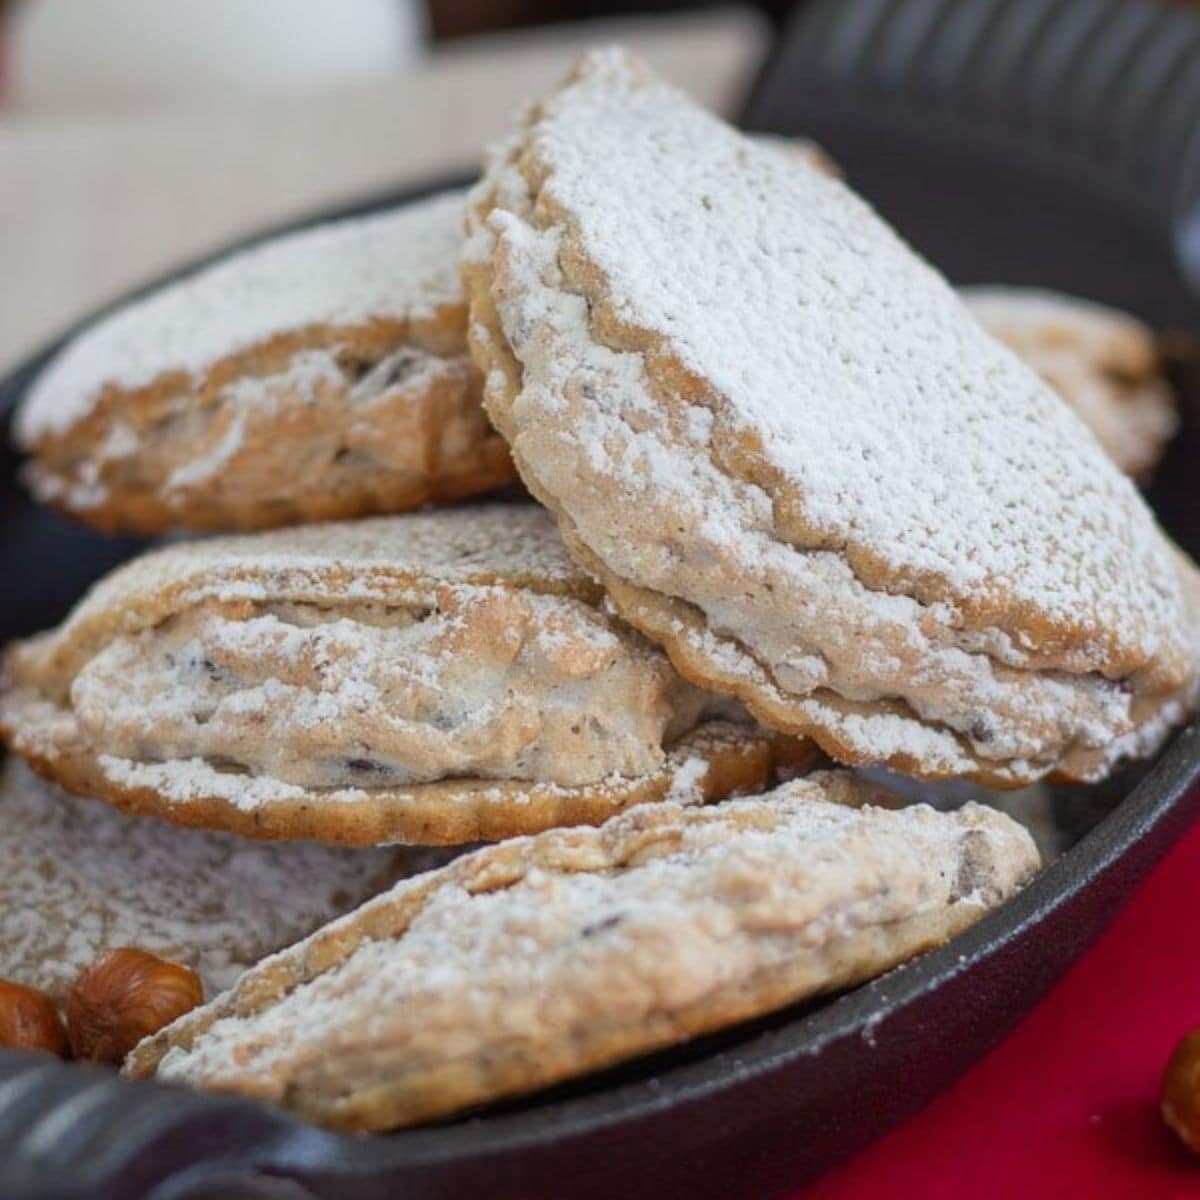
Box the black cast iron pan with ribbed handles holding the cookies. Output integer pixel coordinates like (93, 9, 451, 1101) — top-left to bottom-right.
(0, 0, 1200, 1200)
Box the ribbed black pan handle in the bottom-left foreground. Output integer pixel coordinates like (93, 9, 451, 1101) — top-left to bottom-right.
(0, 1050, 324, 1200)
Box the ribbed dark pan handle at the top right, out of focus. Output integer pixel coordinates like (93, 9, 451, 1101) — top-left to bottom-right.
(750, 0, 1200, 281)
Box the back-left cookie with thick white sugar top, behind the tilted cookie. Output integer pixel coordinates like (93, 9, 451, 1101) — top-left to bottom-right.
(16, 192, 512, 533)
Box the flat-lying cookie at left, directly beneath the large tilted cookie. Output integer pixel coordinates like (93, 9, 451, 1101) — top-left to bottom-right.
(0, 505, 792, 845)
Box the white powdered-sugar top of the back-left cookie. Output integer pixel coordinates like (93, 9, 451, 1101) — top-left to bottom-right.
(17, 192, 462, 443)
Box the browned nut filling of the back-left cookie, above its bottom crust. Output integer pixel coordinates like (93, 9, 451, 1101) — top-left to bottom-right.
(29, 344, 508, 523)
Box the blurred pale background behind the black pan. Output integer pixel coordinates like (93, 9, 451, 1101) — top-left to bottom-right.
(0, 0, 1195, 371)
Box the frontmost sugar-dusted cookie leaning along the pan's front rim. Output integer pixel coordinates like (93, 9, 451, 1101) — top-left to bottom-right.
(126, 775, 1038, 1132)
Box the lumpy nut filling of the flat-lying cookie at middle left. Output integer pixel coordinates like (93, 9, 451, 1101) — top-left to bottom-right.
(71, 587, 702, 788)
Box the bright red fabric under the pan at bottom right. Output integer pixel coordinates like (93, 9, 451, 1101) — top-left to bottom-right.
(793, 787, 1200, 1200)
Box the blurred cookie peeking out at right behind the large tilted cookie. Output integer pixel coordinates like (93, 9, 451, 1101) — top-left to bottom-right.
(962, 287, 1178, 480)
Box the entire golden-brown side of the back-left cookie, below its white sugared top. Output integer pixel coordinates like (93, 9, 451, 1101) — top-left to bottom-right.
(26, 306, 514, 534)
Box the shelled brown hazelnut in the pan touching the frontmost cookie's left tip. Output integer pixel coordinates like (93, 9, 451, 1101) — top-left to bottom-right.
(67, 946, 204, 1063)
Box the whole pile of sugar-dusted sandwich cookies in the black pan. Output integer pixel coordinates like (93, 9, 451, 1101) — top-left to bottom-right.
(0, 50, 1200, 1132)
